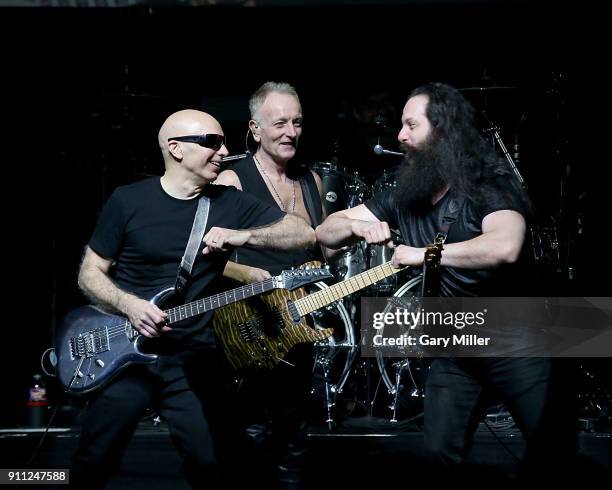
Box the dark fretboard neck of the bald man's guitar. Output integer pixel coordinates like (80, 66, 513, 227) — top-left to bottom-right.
(165, 277, 276, 324)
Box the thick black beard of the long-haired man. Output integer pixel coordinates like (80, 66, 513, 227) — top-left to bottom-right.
(395, 136, 448, 210)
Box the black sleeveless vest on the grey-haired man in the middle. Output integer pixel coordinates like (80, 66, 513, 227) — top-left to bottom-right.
(230, 156, 322, 275)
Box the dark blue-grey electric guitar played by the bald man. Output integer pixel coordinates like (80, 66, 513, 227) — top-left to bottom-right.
(55, 268, 331, 394)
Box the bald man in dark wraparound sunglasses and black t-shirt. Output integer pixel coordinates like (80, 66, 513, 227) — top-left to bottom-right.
(71, 110, 315, 489)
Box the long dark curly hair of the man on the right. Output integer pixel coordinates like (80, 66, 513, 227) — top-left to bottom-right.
(410, 83, 532, 215)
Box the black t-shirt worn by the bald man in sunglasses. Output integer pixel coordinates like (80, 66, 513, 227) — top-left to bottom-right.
(89, 177, 284, 357)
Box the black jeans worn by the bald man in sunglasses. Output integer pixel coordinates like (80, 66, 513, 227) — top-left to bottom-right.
(71, 351, 245, 489)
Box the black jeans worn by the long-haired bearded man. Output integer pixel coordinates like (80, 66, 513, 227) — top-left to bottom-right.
(425, 358, 576, 477)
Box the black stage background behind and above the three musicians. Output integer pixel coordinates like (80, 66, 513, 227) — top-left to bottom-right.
(0, 2, 610, 425)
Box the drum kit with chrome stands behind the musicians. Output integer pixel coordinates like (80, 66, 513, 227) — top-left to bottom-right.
(311, 162, 426, 427)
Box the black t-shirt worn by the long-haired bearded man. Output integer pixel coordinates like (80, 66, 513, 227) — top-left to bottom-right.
(365, 190, 521, 296)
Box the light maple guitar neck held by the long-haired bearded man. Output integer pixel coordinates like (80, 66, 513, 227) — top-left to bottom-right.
(294, 262, 403, 316)
